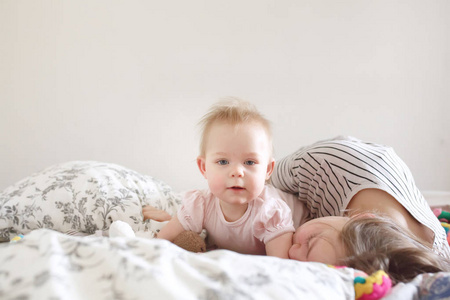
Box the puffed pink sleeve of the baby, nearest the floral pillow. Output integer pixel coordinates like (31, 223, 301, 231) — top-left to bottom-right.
(177, 190, 205, 233)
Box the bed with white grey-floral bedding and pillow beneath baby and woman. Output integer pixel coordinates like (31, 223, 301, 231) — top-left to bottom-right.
(0, 161, 450, 300)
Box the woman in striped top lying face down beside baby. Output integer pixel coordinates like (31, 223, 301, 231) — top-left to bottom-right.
(271, 137, 450, 281)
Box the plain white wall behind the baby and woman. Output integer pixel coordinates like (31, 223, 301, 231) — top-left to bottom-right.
(0, 0, 450, 191)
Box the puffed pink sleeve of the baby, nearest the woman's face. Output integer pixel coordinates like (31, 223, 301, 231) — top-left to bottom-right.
(253, 198, 295, 244)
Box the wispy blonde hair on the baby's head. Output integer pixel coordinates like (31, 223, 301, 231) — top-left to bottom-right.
(199, 97, 273, 156)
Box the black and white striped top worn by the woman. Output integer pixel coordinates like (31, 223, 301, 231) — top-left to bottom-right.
(271, 137, 450, 257)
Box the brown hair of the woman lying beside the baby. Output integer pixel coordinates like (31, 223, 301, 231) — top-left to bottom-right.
(340, 215, 450, 283)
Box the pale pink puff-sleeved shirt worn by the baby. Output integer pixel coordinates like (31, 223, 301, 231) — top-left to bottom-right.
(177, 186, 295, 255)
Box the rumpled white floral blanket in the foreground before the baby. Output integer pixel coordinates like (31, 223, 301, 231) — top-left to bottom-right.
(0, 229, 355, 300)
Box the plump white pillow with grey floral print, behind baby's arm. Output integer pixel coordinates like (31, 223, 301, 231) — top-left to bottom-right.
(0, 161, 181, 240)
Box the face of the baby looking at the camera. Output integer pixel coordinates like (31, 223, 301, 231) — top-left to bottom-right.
(198, 123, 273, 205)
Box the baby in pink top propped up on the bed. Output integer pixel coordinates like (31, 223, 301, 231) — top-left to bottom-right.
(153, 99, 295, 258)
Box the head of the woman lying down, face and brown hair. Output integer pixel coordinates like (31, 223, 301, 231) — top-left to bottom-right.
(289, 214, 449, 282)
